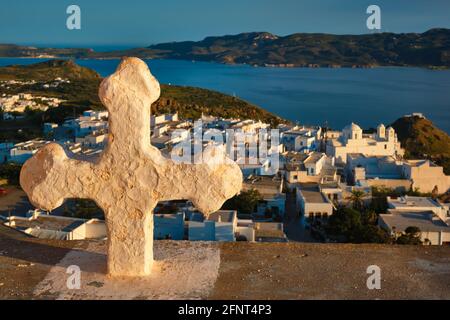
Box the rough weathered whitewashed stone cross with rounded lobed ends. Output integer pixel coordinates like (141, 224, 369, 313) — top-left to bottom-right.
(20, 58, 242, 276)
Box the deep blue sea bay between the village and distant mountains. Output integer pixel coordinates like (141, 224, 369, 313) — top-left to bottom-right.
(0, 58, 450, 133)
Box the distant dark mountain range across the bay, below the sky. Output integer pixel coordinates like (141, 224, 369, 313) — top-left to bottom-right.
(0, 28, 450, 68)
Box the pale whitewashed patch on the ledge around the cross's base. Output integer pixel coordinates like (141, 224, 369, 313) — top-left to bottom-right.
(33, 241, 220, 300)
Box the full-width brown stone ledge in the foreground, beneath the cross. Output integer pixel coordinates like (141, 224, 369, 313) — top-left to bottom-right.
(0, 227, 450, 299)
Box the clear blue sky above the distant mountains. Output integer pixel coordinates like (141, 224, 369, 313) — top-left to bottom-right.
(0, 0, 450, 46)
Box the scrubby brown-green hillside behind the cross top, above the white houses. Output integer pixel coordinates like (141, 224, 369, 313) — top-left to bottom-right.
(0, 60, 283, 131)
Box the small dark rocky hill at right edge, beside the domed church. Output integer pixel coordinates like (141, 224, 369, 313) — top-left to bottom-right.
(392, 117, 450, 175)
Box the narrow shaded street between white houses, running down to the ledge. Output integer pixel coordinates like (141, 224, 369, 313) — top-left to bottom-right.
(284, 192, 318, 242)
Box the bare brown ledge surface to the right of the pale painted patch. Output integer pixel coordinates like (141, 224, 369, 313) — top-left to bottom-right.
(209, 243, 450, 300)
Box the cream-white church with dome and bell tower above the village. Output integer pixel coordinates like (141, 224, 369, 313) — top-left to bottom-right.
(326, 123, 404, 163)
